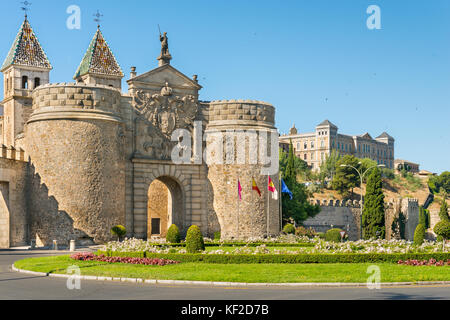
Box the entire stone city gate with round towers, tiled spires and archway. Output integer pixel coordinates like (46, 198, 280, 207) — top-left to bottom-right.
(0, 20, 280, 247)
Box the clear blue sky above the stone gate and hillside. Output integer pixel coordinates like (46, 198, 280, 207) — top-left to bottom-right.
(0, 0, 450, 172)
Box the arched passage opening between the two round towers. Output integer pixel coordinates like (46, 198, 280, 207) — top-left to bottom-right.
(147, 176, 185, 239)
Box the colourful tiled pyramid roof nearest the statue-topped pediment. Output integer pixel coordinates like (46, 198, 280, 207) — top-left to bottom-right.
(73, 28, 124, 79)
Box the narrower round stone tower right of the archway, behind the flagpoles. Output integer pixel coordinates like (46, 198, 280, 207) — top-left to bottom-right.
(205, 100, 281, 239)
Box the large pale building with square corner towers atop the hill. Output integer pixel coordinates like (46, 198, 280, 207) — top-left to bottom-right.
(280, 120, 395, 171)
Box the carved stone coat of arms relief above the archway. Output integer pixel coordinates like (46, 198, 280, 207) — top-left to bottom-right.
(133, 82, 198, 160)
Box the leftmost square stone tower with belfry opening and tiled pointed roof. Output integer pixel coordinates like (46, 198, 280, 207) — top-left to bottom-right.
(0, 16, 52, 146)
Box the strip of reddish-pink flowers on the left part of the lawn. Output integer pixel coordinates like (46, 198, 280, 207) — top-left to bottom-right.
(70, 252, 180, 266)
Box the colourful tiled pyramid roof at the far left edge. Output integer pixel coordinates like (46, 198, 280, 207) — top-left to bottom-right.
(1, 17, 52, 71)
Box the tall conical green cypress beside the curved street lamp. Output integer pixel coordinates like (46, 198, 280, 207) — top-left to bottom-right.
(362, 168, 386, 240)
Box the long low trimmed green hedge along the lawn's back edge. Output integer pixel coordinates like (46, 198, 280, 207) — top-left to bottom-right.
(98, 251, 450, 264)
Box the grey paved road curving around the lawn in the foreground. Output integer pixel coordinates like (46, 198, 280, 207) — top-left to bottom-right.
(0, 251, 450, 300)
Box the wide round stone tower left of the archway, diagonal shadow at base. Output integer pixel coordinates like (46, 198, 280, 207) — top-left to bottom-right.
(25, 83, 125, 245)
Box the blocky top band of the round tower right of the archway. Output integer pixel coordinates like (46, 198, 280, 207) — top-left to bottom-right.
(209, 100, 275, 126)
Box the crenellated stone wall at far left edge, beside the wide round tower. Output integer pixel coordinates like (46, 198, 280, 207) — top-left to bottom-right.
(0, 146, 28, 249)
